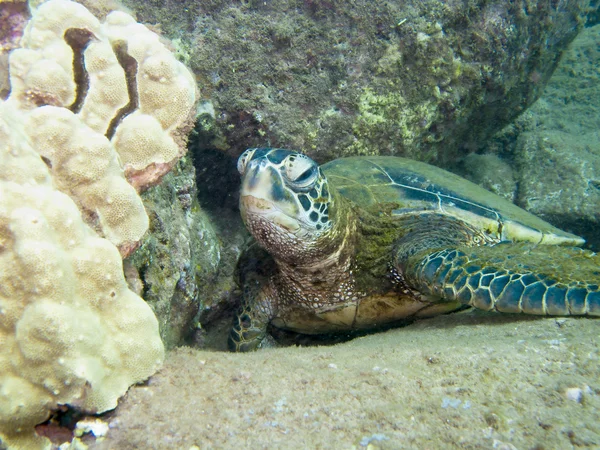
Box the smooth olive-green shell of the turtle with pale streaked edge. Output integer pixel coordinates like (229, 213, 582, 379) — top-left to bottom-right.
(321, 156, 585, 245)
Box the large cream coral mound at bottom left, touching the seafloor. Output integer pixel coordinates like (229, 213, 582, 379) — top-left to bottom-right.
(0, 102, 164, 449)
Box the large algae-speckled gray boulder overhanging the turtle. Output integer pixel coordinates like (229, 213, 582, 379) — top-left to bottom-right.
(126, 0, 589, 163)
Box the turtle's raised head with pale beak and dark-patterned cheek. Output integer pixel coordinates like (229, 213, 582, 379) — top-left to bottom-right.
(238, 148, 333, 261)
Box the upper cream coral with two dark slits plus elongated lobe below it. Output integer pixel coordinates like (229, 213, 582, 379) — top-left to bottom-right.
(8, 0, 196, 256)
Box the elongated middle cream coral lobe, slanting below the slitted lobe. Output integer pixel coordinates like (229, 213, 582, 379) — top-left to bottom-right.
(27, 106, 148, 254)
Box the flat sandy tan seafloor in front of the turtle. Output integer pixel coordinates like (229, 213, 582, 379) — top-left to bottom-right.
(90, 311, 600, 450)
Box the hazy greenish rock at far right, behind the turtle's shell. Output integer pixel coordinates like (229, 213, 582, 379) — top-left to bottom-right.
(463, 25, 600, 250)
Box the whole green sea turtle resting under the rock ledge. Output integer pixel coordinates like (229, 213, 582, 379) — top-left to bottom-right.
(229, 148, 600, 351)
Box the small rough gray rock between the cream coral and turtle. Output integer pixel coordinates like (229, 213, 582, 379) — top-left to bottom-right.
(124, 156, 220, 348)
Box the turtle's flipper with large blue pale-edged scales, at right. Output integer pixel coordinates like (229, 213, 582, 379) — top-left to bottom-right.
(398, 243, 600, 316)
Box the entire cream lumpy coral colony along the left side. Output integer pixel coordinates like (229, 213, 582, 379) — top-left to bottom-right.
(0, 0, 196, 449)
